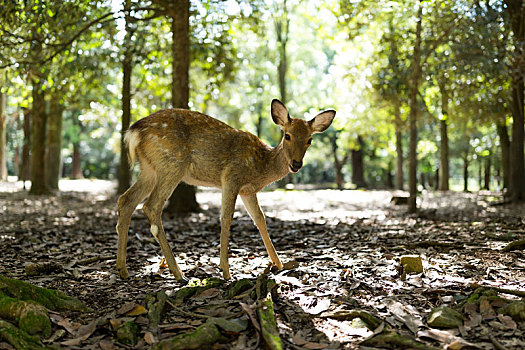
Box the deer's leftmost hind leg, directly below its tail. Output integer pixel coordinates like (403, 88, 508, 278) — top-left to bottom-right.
(116, 163, 156, 278)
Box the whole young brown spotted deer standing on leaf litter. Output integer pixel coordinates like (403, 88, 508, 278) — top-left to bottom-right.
(117, 100, 335, 279)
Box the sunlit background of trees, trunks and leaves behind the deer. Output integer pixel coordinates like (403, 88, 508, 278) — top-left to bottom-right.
(0, 0, 525, 209)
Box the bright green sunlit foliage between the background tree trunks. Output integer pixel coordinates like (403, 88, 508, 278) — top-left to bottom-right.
(0, 0, 514, 191)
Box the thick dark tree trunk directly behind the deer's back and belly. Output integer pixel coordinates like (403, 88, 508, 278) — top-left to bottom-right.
(166, 0, 200, 214)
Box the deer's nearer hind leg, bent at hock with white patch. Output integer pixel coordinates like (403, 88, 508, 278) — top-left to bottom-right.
(142, 169, 184, 280)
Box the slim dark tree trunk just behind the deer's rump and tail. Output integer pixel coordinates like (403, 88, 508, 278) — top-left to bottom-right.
(117, 37, 133, 194)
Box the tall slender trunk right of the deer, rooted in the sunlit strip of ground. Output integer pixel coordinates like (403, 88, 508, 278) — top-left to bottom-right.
(408, 0, 423, 213)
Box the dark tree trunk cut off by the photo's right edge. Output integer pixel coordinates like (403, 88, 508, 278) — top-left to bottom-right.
(505, 0, 525, 202)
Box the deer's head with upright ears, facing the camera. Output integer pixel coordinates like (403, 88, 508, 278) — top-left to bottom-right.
(272, 100, 335, 173)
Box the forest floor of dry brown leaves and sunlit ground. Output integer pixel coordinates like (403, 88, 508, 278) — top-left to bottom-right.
(0, 180, 525, 349)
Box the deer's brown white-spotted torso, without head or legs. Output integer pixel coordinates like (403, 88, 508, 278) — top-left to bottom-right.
(130, 109, 269, 191)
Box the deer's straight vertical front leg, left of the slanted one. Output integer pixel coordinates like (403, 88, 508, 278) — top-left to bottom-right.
(220, 185, 238, 279)
